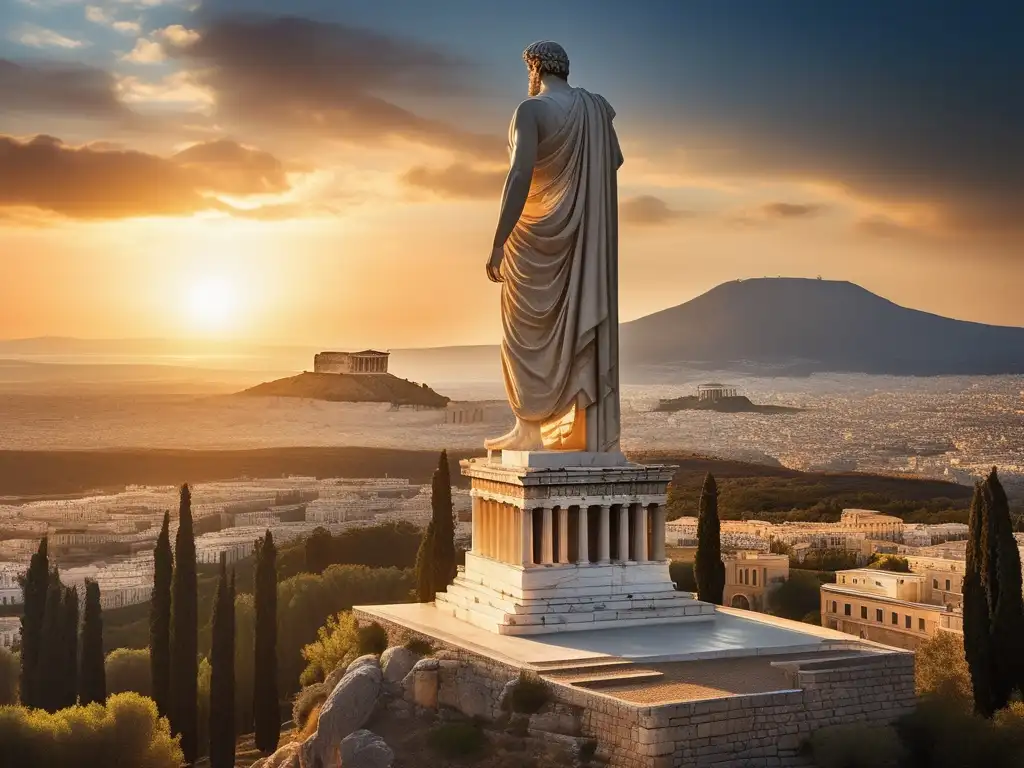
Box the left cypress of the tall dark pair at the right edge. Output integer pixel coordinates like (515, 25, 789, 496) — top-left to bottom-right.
(964, 483, 996, 717)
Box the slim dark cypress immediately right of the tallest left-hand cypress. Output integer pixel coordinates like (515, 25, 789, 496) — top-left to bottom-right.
(209, 554, 234, 768)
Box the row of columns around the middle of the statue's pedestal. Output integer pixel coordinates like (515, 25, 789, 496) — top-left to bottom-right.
(473, 497, 666, 567)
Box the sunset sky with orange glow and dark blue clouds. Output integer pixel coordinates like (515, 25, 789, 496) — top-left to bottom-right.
(0, 0, 1024, 348)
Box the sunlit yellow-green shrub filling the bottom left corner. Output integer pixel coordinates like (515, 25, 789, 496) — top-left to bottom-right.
(0, 693, 182, 768)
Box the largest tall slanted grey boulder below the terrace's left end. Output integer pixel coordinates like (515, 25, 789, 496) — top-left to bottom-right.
(302, 656, 383, 766)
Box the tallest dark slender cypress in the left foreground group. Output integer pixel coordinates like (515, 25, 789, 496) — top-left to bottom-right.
(169, 484, 199, 765)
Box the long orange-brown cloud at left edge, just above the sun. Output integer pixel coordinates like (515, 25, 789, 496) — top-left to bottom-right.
(0, 135, 295, 219)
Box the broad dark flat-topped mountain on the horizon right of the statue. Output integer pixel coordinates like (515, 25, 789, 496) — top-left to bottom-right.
(621, 278, 1024, 376)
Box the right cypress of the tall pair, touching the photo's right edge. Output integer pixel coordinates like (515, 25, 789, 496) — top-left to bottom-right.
(982, 467, 1024, 709)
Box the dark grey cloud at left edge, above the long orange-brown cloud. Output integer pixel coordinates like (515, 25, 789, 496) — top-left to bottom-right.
(0, 58, 132, 120)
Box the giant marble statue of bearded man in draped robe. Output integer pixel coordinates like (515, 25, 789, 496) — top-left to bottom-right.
(484, 41, 623, 452)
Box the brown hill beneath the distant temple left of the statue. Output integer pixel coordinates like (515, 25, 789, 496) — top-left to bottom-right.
(240, 371, 449, 408)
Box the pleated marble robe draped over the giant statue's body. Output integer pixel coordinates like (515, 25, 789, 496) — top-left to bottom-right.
(502, 88, 620, 452)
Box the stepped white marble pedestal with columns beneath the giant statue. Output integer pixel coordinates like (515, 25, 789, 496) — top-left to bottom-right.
(435, 452, 715, 635)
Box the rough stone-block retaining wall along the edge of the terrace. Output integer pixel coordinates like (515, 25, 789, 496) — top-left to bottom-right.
(356, 611, 915, 768)
